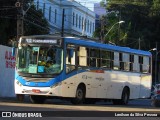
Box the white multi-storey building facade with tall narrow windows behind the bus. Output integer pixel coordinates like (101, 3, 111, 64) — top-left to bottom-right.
(34, 0, 96, 37)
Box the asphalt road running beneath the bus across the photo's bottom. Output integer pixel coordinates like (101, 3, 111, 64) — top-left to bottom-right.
(0, 98, 160, 120)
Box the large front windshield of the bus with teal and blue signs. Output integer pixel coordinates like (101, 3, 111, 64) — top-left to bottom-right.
(16, 44, 63, 74)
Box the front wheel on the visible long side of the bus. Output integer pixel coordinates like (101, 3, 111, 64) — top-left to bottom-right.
(71, 86, 85, 104)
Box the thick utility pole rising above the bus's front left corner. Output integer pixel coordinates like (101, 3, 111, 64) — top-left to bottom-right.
(15, 0, 23, 40)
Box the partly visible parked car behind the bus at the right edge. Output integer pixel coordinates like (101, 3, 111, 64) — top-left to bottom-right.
(151, 84, 160, 107)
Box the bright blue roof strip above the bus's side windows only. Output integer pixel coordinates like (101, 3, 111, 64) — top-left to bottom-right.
(65, 37, 152, 56)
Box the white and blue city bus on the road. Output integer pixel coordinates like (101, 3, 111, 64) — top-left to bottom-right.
(13, 35, 152, 105)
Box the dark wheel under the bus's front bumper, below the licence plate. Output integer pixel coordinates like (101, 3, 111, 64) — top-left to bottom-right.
(30, 95, 46, 104)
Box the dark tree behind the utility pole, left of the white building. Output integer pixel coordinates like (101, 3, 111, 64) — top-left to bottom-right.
(0, 0, 49, 45)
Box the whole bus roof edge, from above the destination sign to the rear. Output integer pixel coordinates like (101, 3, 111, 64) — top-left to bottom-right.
(21, 35, 152, 56)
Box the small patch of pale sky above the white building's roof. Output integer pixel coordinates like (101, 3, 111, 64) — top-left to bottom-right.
(75, 0, 101, 11)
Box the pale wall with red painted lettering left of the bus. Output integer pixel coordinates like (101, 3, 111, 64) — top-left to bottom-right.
(0, 45, 15, 97)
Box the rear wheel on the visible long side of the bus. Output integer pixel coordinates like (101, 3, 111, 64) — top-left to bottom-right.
(120, 87, 129, 105)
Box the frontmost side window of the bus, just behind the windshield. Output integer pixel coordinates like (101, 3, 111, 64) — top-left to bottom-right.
(66, 44, 76, 73)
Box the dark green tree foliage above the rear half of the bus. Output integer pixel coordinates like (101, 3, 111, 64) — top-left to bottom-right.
(94, 0, 160, 50)
